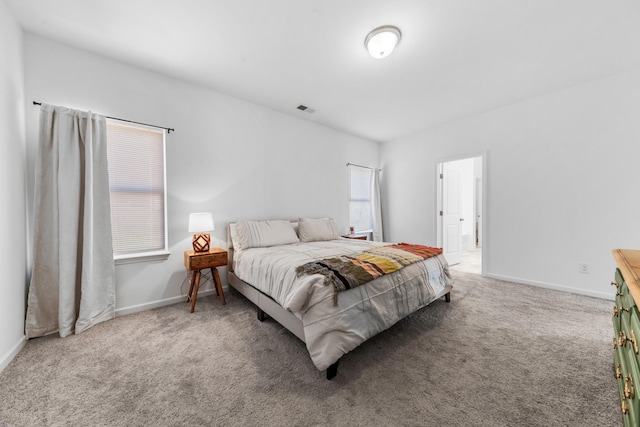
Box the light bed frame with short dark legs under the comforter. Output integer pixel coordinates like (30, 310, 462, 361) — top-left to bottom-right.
(227, 221, 451, 380)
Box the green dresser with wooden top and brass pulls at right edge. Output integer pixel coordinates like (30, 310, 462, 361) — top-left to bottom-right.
(611, 249, 640, 426)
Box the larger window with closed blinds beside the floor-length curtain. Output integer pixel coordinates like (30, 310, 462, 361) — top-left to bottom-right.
(107, 120, 168, 260)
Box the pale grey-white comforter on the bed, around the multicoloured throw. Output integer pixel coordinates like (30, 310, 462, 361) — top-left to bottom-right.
(233, 239, 452, 370)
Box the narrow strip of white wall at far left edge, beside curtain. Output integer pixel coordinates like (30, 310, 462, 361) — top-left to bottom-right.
(0, 0, 27, 371)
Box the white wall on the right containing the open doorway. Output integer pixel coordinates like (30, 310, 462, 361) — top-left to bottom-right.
(380, 69, 640, 298)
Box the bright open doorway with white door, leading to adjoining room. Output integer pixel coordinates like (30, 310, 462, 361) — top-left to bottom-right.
(436, 155, 484, 274)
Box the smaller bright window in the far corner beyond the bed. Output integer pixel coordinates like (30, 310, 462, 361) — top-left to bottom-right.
(349, 165, 373, 233)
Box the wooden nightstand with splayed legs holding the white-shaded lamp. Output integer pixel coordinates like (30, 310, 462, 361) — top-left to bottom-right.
(184, 248, 228, 313)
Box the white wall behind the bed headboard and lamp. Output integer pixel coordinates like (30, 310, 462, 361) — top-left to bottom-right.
(25, 34, 379, 313)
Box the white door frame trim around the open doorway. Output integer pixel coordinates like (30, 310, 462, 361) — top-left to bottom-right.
(433, 150, 490, 276)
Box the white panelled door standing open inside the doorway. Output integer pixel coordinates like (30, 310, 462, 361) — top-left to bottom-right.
(440, 162, 463, 265)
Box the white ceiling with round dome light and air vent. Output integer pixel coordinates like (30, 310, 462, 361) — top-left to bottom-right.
(4, 0, 640, 142)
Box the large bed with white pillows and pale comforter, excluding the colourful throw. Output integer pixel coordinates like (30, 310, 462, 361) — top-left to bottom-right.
(227, 218, 453, 379)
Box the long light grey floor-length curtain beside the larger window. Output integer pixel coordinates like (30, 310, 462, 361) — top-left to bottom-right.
(25, 104, 115, 338)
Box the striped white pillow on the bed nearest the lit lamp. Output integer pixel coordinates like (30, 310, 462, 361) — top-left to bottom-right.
(233, 220, 300, 249)
